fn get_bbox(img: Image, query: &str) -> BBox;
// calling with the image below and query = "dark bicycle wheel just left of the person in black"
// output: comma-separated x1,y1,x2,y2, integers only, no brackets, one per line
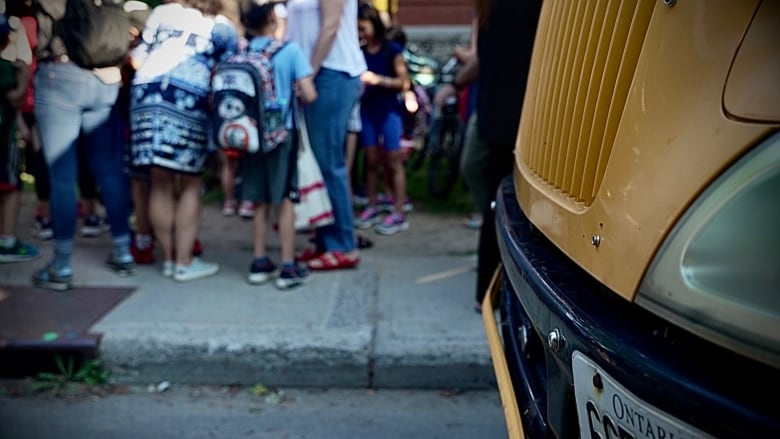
428,117,463,200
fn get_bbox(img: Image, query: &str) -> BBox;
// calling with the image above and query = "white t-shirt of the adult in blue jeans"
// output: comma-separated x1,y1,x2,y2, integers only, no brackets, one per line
287,0,366,77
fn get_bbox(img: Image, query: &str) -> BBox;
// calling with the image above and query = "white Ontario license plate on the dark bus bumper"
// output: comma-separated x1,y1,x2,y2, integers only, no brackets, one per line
572,351,713,439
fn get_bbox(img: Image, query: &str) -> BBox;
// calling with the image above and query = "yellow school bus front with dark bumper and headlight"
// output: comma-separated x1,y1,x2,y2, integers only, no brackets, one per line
483,0,780,439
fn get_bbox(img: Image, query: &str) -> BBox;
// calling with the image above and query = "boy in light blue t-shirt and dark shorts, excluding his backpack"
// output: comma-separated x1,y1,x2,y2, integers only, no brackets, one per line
240,0,317,289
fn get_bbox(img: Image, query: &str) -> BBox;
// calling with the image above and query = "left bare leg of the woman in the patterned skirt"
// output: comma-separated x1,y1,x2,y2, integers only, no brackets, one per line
149,166,175,261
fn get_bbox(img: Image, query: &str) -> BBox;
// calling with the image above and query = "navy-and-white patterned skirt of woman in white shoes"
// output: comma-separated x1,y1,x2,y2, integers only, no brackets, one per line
130,83,213,174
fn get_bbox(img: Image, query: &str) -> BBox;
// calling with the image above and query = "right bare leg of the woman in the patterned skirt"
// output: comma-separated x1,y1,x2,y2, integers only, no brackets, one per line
174,174,203,265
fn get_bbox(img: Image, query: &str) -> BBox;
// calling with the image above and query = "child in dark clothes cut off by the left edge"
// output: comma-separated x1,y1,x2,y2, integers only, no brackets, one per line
0,14,40,263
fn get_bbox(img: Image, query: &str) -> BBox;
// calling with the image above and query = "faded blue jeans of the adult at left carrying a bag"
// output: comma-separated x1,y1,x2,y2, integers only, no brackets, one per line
34,62,130,249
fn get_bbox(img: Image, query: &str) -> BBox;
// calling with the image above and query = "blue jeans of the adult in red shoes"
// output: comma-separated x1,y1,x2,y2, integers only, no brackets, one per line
303,68,360,252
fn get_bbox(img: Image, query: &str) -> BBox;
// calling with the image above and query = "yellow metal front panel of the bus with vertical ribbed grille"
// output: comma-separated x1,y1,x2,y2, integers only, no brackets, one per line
514,0,778,300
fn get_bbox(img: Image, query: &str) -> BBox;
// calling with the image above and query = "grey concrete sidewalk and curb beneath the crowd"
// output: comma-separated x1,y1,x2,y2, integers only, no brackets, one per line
0,193,495,388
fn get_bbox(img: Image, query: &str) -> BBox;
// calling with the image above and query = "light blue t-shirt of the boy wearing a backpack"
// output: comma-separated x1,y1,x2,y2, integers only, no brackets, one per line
247,37,314,129
